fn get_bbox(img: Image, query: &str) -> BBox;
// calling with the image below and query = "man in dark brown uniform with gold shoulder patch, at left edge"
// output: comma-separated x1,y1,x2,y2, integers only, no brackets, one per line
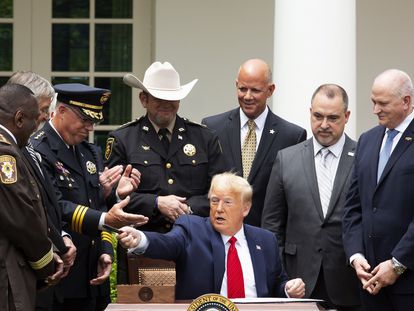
0,84,56,310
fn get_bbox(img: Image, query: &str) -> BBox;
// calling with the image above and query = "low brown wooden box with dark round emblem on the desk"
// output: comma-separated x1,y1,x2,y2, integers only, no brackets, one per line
117,284,175,303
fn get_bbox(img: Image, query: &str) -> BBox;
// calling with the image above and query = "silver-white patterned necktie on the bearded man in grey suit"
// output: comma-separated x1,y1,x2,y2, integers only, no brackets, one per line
317,148,332,217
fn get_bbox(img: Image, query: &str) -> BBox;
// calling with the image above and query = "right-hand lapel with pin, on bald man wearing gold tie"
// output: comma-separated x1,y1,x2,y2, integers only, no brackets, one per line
247,109,279,183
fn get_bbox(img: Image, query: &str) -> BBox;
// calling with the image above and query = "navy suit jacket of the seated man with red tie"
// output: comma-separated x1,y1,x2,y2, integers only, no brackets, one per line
145,215,287,299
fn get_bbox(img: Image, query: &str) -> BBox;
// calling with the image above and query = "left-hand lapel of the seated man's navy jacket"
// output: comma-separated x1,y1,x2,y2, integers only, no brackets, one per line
207,218,225,293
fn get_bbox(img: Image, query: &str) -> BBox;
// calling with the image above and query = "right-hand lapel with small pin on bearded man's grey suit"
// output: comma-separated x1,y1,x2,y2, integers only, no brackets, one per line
325,136,355,220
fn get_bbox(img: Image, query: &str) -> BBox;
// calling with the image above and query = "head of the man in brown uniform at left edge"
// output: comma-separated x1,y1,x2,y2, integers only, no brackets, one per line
0,84,39,147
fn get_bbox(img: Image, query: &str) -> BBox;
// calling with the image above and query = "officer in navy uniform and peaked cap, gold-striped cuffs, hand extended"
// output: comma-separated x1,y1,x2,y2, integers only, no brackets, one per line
31,83,149,311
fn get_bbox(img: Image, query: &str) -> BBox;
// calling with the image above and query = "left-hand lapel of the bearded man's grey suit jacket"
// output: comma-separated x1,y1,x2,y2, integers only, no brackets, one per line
302,138,324,221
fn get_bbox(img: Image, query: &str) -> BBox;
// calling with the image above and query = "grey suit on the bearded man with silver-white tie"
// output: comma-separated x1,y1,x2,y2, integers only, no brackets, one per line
262,137,359,306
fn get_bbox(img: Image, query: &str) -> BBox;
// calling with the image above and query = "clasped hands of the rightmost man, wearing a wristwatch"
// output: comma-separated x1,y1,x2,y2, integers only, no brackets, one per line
352,258,398,295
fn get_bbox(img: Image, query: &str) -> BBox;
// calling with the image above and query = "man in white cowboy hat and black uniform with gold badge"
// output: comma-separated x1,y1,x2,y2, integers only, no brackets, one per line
105,62,224,283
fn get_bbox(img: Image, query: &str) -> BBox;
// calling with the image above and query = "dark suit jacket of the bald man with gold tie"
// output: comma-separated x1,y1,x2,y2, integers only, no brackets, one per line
201,108,306,226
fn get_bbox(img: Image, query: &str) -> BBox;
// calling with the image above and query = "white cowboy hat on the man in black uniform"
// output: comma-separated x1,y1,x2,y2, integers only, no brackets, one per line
123,62,198,100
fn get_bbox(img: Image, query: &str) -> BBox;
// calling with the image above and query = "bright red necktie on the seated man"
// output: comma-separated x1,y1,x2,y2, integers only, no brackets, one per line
227,236,245,298
